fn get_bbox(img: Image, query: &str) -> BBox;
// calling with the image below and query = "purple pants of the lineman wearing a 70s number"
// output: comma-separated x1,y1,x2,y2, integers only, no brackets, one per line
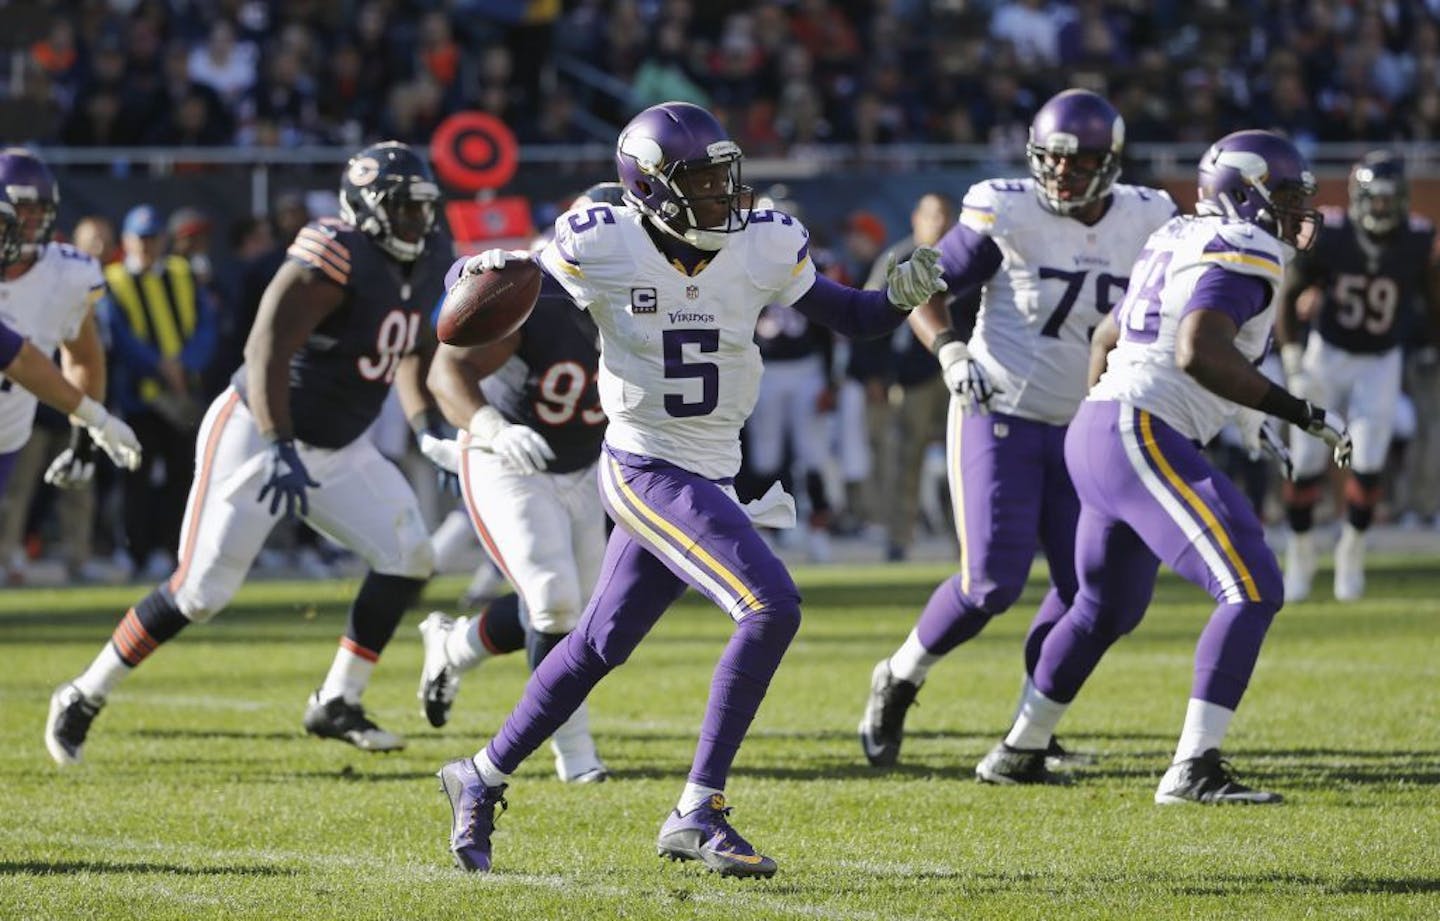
916,400,1080,673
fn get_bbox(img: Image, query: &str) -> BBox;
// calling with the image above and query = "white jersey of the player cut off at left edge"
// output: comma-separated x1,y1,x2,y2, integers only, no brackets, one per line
0,243,105,452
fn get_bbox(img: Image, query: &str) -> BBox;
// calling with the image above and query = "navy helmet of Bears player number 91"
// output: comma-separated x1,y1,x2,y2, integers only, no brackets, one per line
340,141,441,262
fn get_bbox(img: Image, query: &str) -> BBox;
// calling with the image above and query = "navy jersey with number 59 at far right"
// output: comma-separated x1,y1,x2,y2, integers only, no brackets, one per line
1295,209,1436,354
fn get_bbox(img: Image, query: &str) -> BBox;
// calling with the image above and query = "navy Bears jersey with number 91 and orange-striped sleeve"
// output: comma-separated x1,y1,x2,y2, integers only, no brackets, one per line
232,219,452,448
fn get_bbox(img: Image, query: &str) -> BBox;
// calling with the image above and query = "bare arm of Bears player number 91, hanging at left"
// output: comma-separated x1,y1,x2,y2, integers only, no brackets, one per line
245,262,346,440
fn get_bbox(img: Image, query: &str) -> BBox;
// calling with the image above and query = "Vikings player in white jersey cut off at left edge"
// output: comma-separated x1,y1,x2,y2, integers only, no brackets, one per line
0,147,140,489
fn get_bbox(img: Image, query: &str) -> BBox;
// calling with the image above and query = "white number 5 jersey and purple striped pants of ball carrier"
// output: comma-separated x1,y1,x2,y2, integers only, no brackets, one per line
487,204,904,789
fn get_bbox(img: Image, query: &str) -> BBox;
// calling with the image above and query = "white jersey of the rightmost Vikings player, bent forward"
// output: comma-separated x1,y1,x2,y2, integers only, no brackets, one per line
1090,216,1286,443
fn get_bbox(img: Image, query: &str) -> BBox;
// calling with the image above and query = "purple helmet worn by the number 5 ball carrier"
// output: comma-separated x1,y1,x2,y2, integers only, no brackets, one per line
615,102,753,249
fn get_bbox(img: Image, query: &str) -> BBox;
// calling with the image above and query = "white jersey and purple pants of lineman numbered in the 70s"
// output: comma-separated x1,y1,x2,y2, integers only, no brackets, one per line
916,178,1175,659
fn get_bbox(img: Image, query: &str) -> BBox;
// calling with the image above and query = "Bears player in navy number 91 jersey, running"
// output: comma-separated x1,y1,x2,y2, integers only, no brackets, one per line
45,142,452,764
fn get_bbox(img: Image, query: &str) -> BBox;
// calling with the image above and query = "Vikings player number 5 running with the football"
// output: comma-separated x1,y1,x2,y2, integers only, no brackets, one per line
439,102,945,876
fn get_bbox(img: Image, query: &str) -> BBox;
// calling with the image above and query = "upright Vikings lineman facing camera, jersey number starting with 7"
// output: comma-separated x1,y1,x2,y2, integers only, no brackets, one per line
860,89,1176,766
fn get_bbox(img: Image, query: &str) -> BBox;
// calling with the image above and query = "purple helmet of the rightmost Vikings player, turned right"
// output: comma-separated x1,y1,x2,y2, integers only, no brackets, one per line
1195,130,1320,249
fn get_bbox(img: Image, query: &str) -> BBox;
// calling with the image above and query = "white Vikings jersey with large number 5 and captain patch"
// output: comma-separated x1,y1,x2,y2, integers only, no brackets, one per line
540,204,815,479
